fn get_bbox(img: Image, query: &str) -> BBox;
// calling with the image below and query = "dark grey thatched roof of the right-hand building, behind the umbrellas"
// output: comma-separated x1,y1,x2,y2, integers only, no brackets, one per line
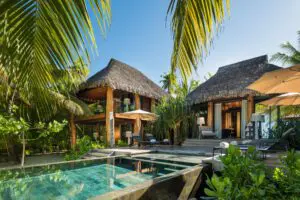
187,55,280,104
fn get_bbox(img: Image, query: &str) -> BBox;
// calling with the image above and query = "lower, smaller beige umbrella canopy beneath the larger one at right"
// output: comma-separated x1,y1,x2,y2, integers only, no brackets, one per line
259,93,300,106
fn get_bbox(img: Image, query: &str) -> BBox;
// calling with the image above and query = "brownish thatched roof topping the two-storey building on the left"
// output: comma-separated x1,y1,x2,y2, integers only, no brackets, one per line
81,59,166,99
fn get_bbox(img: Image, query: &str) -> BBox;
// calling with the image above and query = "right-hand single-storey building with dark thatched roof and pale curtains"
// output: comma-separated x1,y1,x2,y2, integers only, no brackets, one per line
187,55,280,138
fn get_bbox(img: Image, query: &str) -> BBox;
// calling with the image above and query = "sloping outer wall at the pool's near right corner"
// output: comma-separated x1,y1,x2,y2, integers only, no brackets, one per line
93,165,203,200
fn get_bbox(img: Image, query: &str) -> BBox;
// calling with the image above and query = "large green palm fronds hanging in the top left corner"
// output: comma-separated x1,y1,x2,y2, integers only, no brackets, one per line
0,0,111,113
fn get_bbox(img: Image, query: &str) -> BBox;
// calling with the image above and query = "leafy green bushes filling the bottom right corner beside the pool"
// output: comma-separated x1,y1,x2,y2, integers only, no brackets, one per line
205,146,300,200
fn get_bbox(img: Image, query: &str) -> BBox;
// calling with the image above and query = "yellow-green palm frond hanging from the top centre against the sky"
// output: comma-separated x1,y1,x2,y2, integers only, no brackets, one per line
168,0,230,82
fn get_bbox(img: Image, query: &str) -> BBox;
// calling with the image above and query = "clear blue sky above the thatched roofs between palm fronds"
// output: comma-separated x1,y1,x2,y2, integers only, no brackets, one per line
90,0,300,84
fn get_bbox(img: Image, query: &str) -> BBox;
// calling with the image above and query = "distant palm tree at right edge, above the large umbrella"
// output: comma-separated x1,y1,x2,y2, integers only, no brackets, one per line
271,31,300,65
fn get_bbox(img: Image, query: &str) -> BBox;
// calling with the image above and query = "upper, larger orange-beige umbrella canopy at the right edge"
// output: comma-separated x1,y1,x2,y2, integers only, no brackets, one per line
247,65,300,94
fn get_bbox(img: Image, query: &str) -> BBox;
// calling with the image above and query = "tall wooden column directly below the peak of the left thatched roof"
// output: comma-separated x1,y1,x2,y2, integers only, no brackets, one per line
105,87,114,144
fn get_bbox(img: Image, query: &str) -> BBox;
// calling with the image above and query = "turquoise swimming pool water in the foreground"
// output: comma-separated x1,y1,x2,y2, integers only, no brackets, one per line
0,157,197,199
